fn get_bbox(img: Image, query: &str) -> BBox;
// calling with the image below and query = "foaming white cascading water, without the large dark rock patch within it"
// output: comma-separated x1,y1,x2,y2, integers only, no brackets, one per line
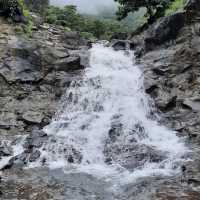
34,44,186,183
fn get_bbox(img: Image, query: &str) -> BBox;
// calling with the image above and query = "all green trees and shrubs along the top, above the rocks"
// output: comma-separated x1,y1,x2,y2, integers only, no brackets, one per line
0,0,186,41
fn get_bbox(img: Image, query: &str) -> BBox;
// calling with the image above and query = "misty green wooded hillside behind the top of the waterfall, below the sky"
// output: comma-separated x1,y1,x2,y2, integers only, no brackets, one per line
45,6,150,41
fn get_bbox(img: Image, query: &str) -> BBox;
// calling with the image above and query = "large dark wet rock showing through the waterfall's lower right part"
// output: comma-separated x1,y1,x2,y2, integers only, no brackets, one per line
104,115,166,171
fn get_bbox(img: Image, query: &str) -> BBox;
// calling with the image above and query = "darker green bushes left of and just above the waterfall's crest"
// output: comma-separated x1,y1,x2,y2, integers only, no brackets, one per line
45,6,122,40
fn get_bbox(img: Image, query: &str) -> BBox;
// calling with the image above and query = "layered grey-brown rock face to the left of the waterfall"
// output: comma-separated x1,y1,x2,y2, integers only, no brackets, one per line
0,18,88,170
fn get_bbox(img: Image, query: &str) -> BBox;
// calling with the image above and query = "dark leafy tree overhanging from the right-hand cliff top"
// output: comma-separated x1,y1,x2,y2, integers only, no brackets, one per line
115,0,175,24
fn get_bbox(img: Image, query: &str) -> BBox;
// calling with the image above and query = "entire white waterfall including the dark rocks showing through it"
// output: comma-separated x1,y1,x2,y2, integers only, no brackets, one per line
0,44,187,199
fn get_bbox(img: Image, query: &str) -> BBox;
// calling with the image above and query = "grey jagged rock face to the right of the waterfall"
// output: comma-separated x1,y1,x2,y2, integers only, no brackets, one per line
133,0,200,200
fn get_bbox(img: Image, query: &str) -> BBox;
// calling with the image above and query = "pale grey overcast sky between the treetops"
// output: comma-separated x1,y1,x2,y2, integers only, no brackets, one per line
50,0,115,14
